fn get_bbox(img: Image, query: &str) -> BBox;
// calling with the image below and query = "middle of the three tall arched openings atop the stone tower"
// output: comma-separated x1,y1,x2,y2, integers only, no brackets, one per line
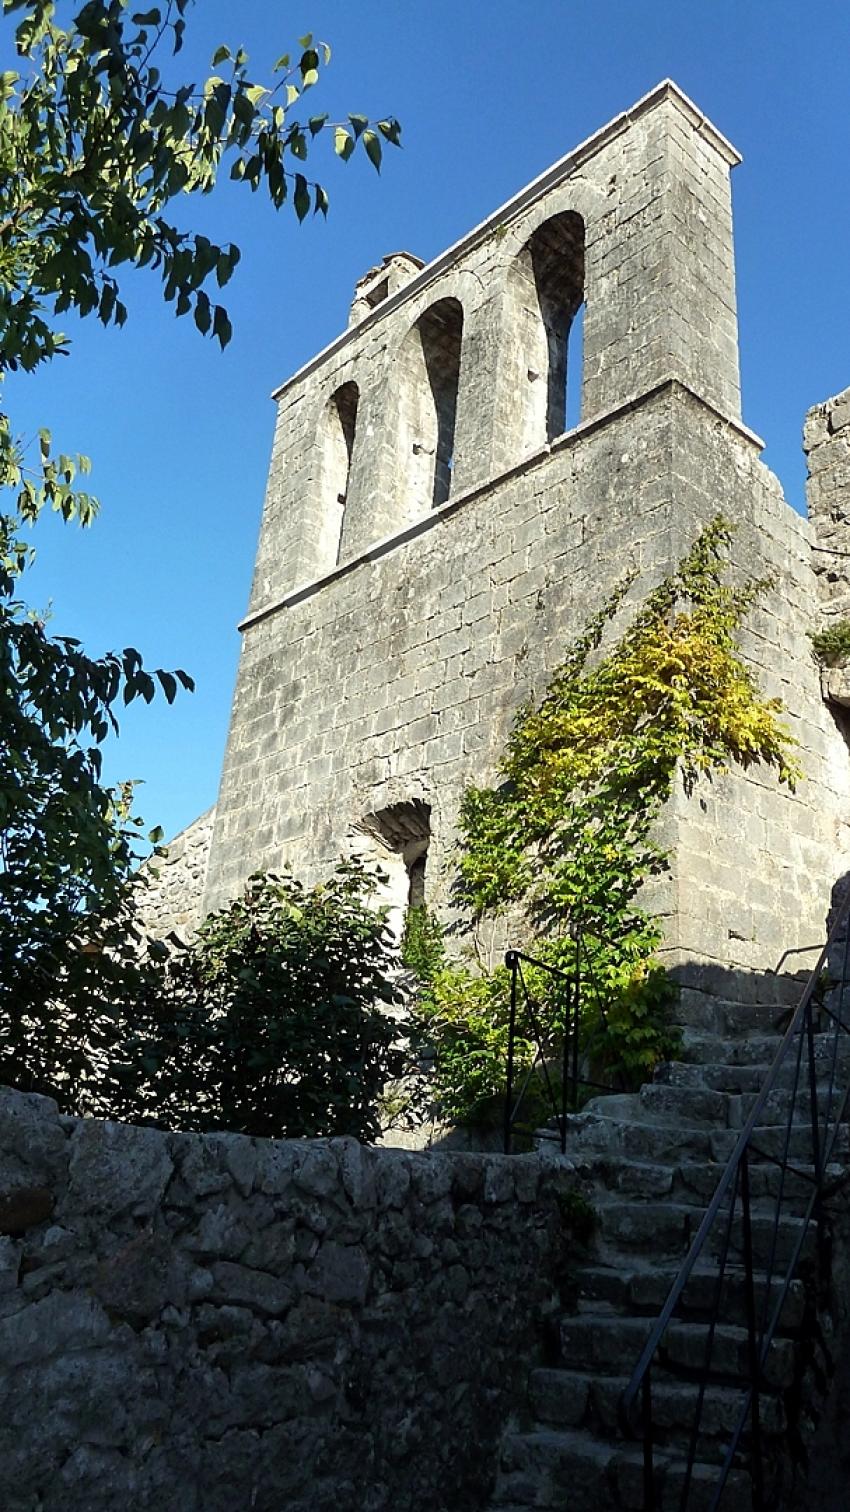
399,298,463,519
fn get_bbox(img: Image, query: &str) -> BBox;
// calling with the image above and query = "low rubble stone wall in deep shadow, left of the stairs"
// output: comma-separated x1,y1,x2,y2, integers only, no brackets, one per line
0,1092,573,1512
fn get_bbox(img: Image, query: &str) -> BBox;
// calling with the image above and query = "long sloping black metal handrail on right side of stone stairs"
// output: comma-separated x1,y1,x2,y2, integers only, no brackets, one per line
620,892,850,1512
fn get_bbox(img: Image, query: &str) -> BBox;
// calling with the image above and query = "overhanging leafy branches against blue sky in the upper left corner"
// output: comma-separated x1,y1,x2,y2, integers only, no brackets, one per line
0,0,399,370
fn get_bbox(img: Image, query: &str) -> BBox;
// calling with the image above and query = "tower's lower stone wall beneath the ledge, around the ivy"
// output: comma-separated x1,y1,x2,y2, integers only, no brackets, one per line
199,373,850,971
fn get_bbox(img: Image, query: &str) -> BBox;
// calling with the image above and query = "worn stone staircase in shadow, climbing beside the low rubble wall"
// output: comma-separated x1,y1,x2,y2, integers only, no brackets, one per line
490,983,850,1512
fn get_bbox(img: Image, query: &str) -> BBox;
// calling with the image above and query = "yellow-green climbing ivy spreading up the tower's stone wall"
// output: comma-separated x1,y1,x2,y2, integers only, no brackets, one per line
419,516,802,1120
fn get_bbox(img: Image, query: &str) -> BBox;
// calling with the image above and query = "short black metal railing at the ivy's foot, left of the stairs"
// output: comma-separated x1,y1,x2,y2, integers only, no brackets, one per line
504,931,622,1155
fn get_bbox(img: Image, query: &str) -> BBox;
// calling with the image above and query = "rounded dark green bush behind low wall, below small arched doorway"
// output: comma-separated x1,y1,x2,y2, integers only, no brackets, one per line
127,862,402,1140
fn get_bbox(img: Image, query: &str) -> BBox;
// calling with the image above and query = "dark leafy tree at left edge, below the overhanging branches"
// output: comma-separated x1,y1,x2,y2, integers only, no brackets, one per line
0,486,192,1003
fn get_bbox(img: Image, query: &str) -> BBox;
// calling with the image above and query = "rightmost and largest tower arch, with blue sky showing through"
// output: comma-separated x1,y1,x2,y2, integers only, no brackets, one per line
508,210,584,452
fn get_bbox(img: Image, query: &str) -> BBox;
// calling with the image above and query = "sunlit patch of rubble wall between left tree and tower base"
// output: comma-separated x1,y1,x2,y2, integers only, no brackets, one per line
136,807,215,939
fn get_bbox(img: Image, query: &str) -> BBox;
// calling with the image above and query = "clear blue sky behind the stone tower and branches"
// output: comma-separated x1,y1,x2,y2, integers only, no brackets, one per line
6,0,850,833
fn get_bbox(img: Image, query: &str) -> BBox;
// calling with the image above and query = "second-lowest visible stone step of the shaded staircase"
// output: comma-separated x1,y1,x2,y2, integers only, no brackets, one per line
529,1368,786,1433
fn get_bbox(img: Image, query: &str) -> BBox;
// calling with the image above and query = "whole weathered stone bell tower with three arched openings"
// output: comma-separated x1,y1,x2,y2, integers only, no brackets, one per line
176,83,850,971
